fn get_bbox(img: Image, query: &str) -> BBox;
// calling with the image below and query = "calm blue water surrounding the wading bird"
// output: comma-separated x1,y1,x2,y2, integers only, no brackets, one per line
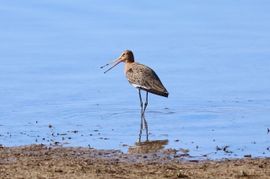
0,0,270,157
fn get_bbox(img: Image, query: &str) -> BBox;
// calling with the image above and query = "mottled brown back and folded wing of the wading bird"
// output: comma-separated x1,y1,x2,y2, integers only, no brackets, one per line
126,62,169,97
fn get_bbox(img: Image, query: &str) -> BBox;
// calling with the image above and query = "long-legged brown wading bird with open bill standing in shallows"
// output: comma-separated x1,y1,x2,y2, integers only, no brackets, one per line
100,50,169,142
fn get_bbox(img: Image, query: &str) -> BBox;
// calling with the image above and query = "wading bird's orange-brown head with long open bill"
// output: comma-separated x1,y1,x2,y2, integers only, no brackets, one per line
100,50,134,73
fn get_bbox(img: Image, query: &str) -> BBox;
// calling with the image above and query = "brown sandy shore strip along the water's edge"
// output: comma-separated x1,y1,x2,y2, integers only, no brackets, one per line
0,145,270,178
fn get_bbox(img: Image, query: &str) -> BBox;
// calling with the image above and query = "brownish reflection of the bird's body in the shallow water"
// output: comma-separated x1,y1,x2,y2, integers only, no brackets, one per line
128,140,169,154
